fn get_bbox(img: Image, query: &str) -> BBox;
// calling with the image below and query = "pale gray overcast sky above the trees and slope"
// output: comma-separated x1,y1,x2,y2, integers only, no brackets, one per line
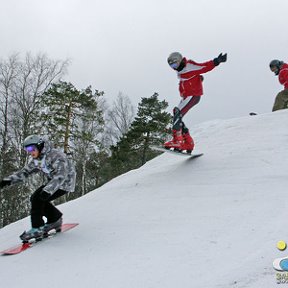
0,0,288,126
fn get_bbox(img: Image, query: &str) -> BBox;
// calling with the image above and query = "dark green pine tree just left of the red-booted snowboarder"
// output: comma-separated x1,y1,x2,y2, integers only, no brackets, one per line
111,93,171,174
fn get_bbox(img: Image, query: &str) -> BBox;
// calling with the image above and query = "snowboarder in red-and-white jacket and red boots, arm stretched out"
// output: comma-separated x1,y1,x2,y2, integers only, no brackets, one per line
164,52,227,153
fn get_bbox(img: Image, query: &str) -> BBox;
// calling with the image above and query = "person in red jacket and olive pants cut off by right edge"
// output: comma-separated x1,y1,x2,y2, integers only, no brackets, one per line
269,59,288,112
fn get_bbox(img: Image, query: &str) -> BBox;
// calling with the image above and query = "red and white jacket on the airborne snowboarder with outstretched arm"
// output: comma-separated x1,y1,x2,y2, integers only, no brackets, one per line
177,58,215,99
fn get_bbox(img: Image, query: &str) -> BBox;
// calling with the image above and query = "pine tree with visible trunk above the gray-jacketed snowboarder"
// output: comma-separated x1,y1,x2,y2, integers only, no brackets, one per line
41,81,101,153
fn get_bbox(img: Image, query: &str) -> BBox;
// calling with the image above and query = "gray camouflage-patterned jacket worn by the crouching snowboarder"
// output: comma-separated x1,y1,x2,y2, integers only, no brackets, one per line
5,141,76,195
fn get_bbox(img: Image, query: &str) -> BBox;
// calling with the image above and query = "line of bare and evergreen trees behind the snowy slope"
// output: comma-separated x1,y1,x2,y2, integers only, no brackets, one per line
0,53,171,227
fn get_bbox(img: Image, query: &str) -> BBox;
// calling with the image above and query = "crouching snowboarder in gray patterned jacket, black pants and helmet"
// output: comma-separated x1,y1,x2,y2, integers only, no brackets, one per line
0,135,76,241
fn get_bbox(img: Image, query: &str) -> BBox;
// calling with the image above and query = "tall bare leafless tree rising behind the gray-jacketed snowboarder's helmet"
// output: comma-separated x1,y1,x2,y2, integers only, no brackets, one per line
11,53,68,165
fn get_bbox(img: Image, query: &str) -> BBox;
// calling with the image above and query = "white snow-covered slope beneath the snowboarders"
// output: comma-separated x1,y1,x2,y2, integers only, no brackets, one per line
0,110,288,288
